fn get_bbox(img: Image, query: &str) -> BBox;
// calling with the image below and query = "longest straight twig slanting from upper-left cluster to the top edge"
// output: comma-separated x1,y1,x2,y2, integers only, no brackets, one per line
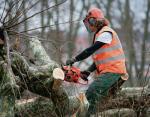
6,0,67,29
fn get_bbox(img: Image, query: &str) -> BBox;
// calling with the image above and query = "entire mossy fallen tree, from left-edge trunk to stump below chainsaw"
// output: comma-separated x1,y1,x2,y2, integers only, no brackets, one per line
1,32,84,117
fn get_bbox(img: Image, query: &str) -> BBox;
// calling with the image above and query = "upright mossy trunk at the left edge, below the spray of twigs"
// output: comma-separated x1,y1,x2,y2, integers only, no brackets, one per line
0,30,18,117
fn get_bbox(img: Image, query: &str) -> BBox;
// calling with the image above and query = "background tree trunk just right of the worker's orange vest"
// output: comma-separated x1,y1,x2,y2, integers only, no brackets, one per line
122,0,136,86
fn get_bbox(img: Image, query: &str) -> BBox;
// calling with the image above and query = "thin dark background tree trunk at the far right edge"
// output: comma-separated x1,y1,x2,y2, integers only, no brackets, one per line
139,0,150,85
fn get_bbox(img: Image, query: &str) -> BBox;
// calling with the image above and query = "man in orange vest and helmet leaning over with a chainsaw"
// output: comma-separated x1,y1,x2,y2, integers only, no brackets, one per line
66,8,127,117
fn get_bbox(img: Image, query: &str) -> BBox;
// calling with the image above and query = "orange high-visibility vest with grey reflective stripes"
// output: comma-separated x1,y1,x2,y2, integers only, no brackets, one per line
93,26,127,75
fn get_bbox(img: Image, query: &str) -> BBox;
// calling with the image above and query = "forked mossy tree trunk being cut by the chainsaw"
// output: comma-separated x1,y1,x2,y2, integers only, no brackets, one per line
11,38,80,116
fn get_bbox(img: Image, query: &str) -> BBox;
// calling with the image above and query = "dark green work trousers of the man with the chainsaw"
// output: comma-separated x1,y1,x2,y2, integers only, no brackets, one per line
86,73,124,117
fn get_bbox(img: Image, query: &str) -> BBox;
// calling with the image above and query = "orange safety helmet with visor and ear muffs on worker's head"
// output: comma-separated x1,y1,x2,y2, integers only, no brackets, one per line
83,8,109,32
